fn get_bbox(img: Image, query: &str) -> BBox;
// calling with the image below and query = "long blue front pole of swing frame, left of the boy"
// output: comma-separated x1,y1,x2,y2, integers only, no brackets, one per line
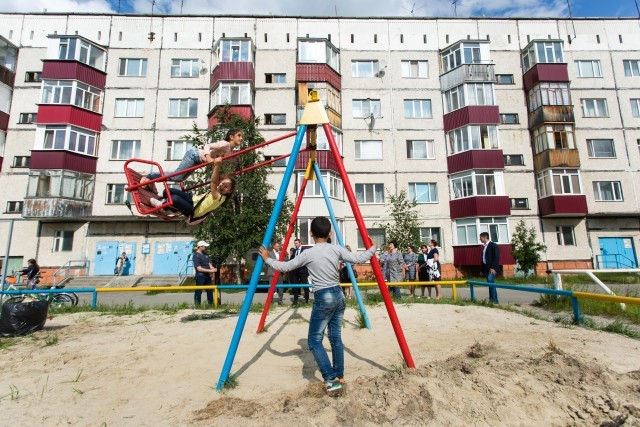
216,125,307,391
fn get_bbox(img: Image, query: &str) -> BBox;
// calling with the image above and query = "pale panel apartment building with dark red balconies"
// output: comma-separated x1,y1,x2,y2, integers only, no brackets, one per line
0,14,640,276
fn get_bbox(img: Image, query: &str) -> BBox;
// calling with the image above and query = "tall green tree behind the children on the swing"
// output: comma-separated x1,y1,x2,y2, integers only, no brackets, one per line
185,106,293,278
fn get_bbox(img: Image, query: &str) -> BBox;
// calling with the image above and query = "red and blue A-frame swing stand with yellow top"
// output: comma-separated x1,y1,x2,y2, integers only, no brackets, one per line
216,91,415,391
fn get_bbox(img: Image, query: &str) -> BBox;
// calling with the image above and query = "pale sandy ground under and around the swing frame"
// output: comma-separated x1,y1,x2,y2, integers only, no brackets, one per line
0,304,640,426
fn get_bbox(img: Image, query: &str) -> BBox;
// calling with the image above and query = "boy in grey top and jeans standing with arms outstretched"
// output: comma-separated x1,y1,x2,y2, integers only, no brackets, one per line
260,217,376,393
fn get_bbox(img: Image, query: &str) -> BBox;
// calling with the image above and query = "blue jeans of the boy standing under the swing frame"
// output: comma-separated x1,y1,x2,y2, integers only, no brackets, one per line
308,286,347,381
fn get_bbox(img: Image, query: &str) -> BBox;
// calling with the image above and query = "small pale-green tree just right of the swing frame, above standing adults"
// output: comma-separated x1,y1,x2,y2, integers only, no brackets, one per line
376,190,420,251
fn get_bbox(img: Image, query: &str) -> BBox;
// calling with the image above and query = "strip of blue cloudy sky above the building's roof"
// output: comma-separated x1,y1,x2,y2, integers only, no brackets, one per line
0,0,640,17
